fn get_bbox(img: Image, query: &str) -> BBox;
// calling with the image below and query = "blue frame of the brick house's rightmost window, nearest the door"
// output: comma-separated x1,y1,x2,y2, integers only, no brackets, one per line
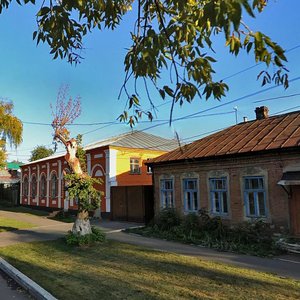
243,175,268,219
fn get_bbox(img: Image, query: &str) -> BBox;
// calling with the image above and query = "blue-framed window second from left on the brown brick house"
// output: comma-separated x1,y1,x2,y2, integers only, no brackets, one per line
183,179,199,212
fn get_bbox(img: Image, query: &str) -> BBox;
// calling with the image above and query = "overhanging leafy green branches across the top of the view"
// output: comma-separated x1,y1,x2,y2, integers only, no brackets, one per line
0,0,288,125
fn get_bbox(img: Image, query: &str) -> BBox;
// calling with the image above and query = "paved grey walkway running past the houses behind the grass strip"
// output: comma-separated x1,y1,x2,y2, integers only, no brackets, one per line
0,211,300,279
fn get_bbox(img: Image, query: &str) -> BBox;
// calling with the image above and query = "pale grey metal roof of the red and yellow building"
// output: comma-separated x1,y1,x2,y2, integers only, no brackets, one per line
23,131,178,167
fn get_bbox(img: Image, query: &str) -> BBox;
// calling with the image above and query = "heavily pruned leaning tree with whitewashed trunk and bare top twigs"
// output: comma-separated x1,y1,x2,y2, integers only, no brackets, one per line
52,87,101,236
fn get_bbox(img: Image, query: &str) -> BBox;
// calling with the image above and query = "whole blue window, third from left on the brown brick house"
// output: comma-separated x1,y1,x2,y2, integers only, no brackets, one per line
209,177,228,215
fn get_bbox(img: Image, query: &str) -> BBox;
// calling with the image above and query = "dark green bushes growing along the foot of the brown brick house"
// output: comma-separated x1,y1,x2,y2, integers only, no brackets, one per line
132,209,278,256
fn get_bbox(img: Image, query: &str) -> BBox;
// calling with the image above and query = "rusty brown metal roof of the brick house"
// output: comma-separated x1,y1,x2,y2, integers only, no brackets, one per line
151,111,300,163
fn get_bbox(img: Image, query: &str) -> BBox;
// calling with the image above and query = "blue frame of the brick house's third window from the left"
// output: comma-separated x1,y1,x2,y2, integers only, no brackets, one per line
208,176,229,217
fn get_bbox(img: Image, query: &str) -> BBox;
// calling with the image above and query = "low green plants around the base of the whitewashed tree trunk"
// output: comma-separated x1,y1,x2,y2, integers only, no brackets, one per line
65,227,105,246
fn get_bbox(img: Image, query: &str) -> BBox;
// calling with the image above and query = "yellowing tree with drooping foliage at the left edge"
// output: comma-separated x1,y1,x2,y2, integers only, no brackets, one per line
0,100,23,168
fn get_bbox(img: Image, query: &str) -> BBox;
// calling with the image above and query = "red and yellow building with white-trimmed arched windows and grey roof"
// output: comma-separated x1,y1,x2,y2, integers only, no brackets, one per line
20,131,177,218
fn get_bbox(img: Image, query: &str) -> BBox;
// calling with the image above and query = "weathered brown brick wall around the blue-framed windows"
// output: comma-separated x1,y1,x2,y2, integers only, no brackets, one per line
152,151,300,228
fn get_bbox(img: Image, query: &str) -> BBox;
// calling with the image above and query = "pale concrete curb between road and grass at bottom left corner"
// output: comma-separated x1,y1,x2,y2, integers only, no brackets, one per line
0,257,57,300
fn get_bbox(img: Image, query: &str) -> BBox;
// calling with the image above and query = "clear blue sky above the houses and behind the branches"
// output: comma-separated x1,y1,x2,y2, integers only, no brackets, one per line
0,0,300,162
